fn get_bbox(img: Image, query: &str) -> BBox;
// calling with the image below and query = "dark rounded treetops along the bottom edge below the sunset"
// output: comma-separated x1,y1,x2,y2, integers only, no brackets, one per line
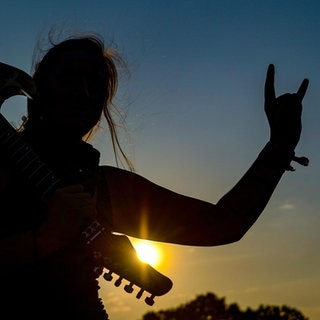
142,292,308,320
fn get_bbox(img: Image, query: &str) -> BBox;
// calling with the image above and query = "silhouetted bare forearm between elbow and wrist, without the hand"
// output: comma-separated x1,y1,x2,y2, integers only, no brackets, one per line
217,143,294,240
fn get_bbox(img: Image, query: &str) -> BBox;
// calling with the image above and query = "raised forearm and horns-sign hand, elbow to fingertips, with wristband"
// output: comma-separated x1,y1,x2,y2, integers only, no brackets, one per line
217,65,309,238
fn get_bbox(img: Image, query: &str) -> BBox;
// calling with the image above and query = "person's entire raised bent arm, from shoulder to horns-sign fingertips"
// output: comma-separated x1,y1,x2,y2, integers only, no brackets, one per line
101,65,308,246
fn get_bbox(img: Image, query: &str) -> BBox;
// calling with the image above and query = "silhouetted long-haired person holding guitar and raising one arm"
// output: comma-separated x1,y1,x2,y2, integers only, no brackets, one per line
0,35,308,320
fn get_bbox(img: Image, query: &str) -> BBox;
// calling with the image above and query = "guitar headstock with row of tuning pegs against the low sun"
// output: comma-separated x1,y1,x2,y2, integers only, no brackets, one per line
83,221,172,305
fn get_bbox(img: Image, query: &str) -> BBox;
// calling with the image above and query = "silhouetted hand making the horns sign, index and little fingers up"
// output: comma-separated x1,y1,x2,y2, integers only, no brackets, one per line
264,64,309,150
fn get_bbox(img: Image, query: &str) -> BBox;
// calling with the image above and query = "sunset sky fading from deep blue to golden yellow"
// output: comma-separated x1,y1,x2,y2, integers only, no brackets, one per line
0,0,320,320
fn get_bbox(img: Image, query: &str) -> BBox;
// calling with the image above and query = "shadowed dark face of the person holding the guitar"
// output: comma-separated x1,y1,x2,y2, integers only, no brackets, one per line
40,50,108,137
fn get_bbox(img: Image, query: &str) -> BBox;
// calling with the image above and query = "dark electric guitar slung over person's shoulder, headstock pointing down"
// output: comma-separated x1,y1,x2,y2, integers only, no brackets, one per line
0,63,172,305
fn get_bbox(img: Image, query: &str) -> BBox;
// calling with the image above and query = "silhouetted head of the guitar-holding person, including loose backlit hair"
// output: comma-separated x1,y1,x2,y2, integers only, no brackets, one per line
24,35,130,170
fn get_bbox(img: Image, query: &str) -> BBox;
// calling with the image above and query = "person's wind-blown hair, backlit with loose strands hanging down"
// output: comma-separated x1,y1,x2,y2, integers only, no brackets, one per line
22,34,133,170
